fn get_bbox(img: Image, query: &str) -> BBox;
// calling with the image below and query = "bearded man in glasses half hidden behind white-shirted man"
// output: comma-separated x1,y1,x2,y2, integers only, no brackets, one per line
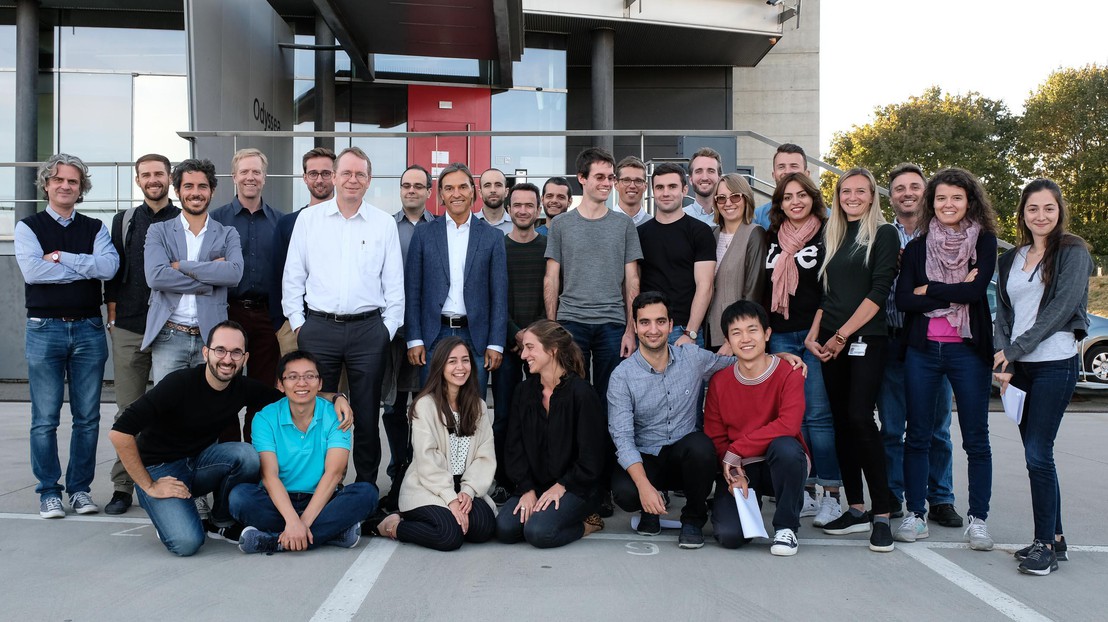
269,146,335,356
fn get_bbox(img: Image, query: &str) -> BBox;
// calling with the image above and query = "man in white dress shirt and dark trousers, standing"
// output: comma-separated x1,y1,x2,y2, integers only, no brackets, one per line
281,146,404,483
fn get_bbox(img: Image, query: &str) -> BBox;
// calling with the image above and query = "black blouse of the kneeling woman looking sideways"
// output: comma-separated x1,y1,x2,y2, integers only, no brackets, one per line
504,374,611,498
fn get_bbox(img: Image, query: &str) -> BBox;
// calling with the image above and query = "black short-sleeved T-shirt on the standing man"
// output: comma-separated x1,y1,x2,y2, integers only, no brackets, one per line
638,216,716,326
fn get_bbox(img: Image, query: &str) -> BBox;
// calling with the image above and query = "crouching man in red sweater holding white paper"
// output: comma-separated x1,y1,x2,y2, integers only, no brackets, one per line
704,300,809,557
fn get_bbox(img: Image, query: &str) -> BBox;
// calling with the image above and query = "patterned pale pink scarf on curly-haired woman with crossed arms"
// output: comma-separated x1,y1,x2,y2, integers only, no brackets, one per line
923,218,981,339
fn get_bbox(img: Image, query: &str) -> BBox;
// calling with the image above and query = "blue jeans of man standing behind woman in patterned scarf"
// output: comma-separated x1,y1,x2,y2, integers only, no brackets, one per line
878,338,954,507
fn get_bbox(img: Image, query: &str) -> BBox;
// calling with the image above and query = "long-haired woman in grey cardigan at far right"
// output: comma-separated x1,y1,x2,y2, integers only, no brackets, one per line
993,180,1092,575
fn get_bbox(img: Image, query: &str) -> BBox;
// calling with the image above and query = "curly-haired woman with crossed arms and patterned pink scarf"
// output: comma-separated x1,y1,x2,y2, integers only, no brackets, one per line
894,169,996,551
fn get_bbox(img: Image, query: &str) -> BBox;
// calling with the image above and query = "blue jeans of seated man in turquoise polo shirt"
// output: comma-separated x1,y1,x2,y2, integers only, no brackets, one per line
229,481,377,549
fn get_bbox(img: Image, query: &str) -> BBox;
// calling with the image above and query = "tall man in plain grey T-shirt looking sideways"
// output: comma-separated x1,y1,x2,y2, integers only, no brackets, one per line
543,147,643,408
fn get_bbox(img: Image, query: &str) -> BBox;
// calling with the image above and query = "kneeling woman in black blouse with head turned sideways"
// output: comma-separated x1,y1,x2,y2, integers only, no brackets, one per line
496,319,607,549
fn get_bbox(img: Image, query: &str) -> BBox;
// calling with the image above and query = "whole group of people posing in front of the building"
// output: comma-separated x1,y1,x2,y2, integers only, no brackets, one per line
16,144,1091,574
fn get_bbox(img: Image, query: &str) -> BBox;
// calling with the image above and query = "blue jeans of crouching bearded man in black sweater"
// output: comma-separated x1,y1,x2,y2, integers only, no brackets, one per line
135,442,259,557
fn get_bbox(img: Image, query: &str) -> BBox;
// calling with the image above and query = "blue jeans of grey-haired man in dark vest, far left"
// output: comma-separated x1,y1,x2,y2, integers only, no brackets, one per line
25,317,107,500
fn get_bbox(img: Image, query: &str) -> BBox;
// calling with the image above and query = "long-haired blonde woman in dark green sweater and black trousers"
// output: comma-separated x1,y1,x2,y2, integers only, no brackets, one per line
804,169,900,552
